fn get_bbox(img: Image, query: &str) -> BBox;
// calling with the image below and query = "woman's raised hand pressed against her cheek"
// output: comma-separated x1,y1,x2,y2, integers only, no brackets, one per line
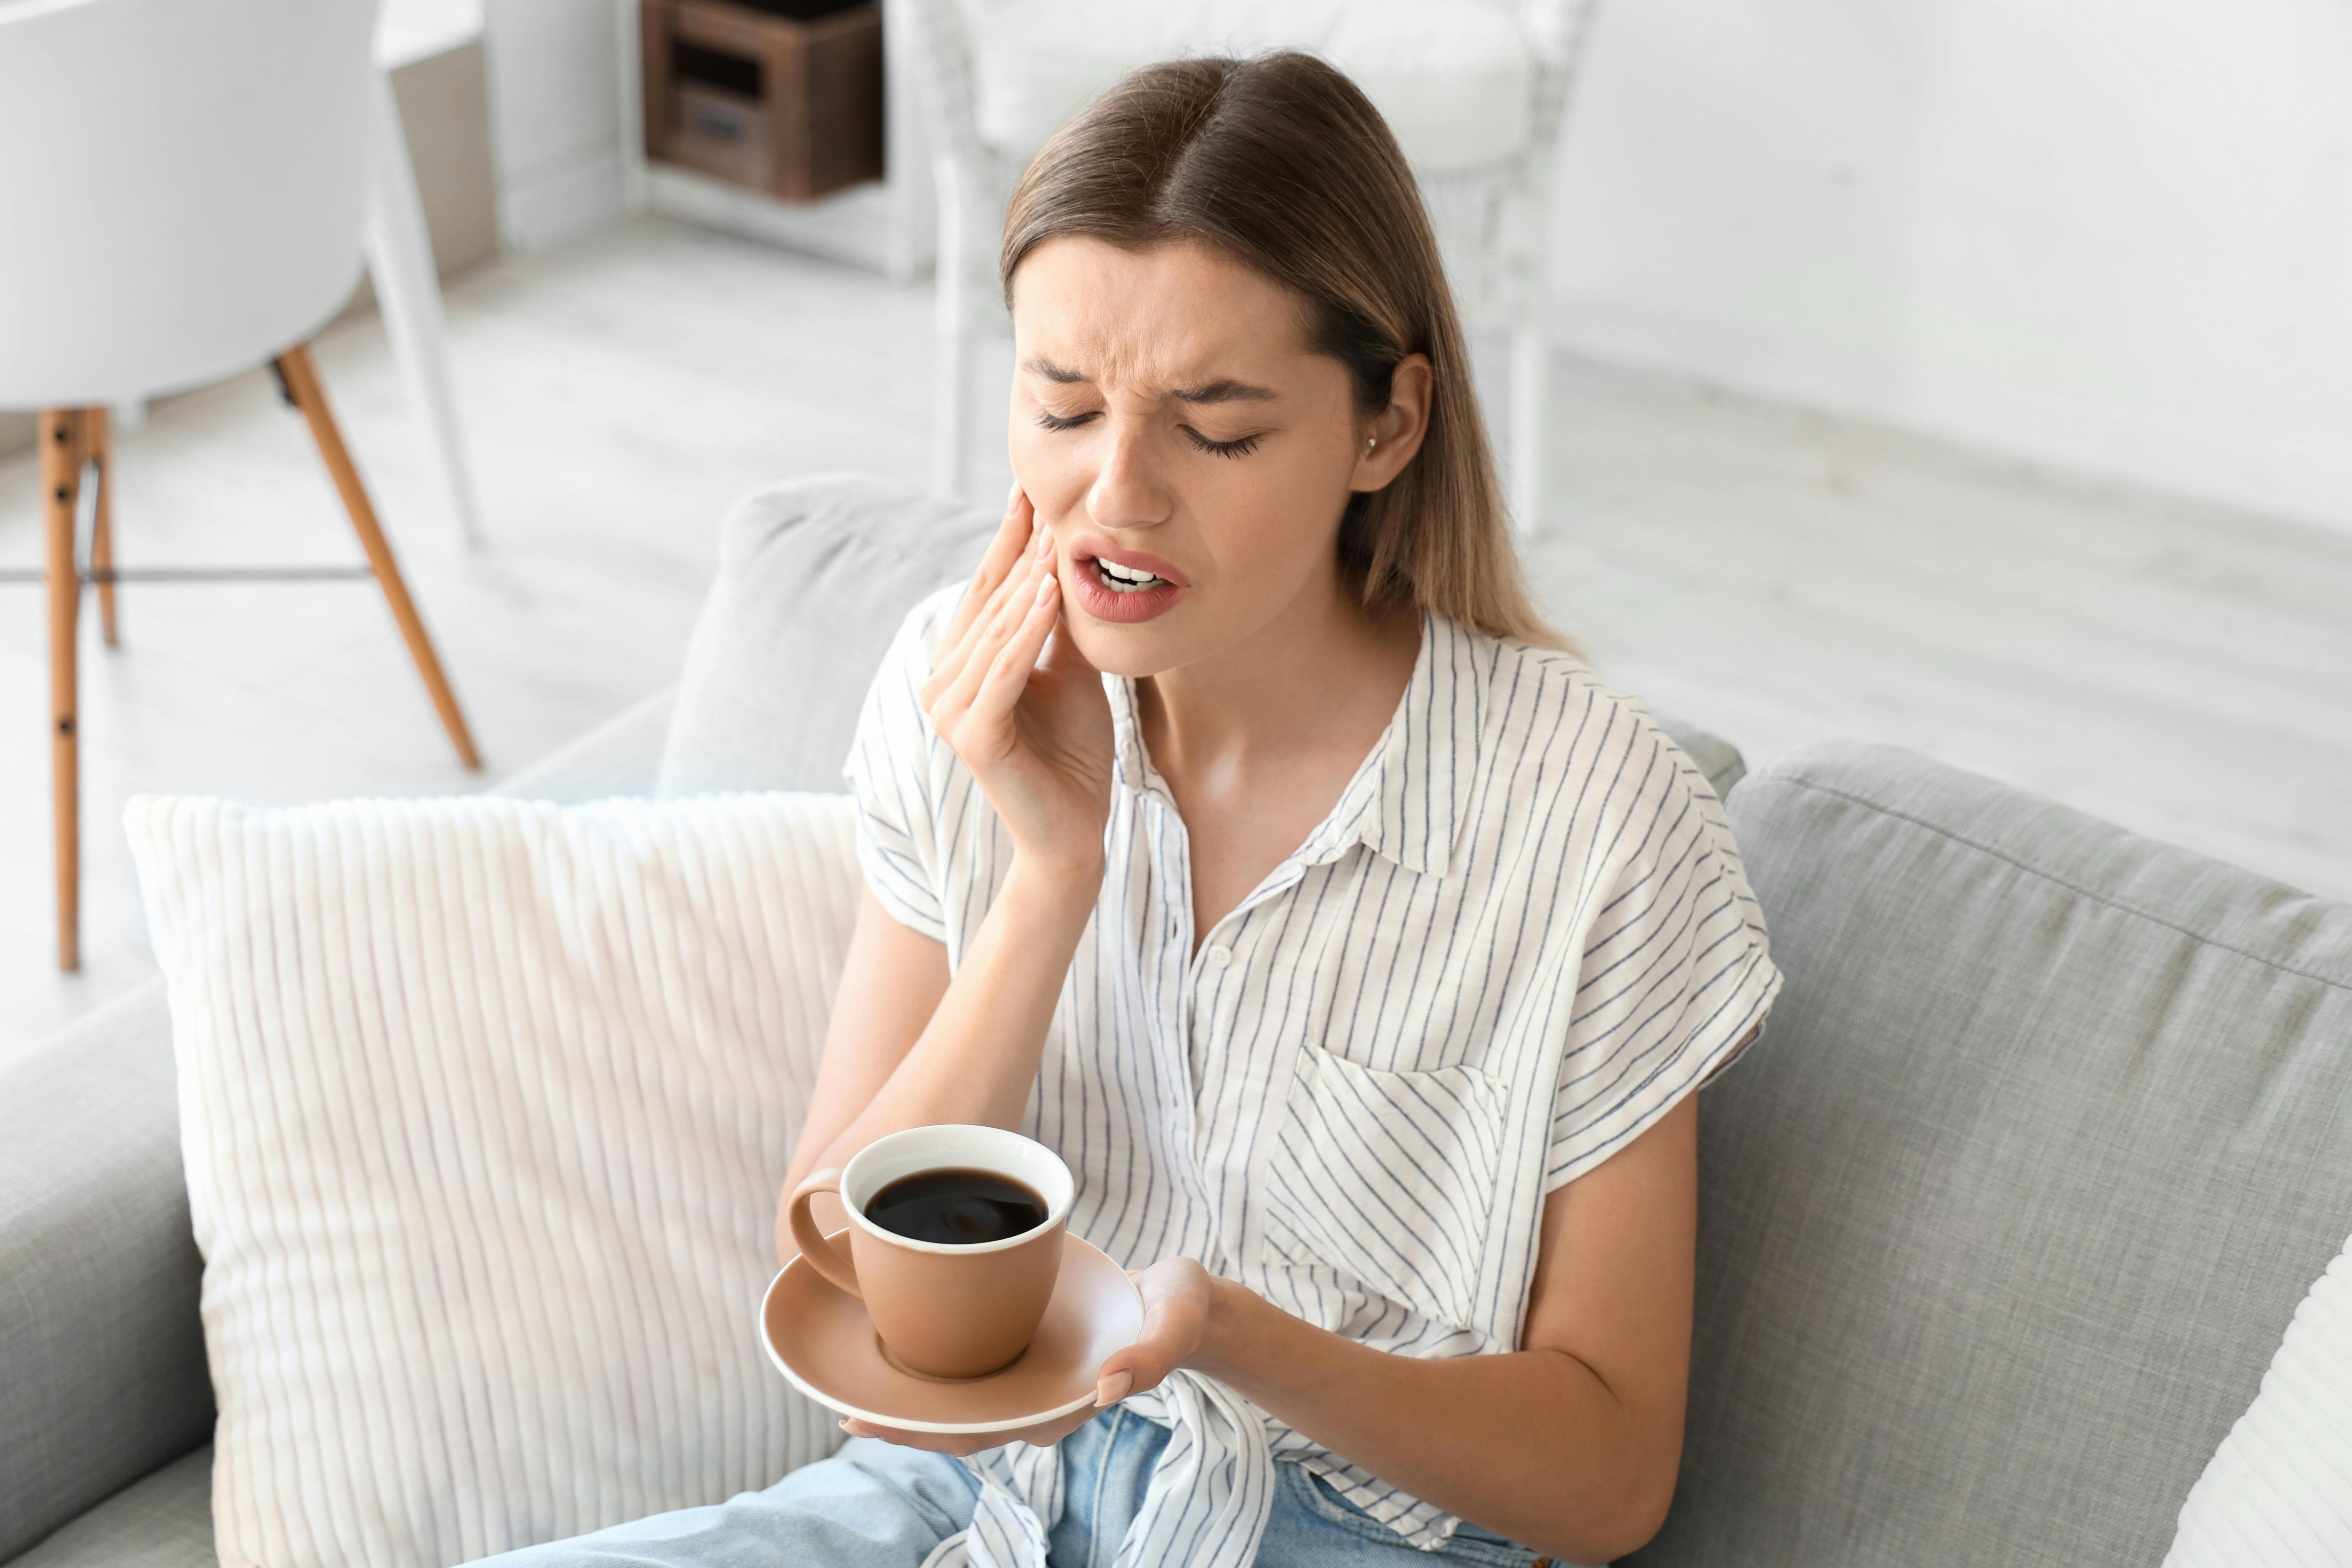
920,484,1113,877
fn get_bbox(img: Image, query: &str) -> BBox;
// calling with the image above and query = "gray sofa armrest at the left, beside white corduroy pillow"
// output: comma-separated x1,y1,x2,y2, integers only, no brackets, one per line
0,983,212,1561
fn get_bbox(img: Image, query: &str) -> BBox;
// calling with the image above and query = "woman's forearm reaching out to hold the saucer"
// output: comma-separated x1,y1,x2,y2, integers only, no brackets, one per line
1188,1279,1682,1563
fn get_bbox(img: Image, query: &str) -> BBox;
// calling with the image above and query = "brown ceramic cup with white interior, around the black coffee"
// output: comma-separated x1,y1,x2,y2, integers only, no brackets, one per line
790,1124,1075,1378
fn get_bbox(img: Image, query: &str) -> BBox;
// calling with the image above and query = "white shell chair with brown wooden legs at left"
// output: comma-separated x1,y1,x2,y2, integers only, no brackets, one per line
0,0,480,968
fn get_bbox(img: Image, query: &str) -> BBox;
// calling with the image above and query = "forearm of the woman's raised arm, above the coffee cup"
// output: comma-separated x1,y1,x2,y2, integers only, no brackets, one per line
793,860,1101,1178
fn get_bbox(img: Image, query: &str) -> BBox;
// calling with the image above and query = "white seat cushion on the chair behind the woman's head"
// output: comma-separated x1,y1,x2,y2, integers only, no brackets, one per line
957,0,1536,174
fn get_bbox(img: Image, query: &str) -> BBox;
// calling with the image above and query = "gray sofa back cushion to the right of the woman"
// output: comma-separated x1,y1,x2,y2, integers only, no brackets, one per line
1628,745,2352,1568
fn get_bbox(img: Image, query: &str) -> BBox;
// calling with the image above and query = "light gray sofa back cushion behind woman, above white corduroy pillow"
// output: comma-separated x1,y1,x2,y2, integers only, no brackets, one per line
654,475,1745,794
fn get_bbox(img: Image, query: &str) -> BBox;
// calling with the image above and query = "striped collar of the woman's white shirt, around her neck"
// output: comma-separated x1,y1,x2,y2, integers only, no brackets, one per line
1103,611,1486,875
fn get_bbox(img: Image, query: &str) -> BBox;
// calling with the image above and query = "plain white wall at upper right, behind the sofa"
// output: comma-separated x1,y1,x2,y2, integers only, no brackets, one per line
1555,0,2352,529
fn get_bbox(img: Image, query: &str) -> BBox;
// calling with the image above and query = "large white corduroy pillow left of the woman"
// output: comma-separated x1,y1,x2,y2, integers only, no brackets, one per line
127,794,859,1568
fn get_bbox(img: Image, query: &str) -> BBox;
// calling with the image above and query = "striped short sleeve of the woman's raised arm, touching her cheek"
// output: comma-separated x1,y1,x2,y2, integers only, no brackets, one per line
842,590,962,943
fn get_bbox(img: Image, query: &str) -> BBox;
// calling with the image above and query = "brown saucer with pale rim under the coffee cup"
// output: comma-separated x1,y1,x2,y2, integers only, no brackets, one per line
760,1232,1143,1432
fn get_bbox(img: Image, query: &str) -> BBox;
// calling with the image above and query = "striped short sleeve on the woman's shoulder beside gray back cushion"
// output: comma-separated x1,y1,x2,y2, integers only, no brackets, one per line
1543,745,1780,1192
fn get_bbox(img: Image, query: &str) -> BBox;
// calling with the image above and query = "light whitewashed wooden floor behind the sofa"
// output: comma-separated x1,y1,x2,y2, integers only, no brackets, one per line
0,223,2352,1058
